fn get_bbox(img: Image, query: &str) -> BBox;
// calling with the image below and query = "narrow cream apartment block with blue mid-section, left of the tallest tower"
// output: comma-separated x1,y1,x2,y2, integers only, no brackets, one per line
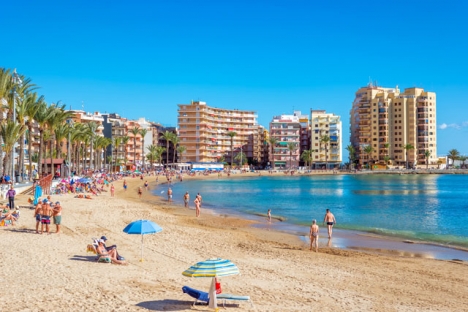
310,110,343,169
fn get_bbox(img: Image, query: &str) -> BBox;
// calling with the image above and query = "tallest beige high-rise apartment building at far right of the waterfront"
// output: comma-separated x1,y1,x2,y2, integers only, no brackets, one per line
350,83,437,167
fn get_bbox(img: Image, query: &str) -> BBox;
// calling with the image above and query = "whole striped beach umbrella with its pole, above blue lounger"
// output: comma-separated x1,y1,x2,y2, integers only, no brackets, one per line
182,258,239,309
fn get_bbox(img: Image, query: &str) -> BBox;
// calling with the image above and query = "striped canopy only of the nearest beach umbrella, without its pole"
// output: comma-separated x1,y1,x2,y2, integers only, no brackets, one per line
182,258,239,277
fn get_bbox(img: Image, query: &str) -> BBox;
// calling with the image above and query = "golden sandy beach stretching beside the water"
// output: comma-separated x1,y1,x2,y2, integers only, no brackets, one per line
0,177,468,311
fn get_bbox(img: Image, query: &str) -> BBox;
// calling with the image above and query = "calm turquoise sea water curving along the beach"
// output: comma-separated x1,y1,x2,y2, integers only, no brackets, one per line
155,174,468,247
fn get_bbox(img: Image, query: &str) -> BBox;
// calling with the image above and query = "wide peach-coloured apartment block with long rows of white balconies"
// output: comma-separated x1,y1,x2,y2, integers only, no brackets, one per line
178,101,258,163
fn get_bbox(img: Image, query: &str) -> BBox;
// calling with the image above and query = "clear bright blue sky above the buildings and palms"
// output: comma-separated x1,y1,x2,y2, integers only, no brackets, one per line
0,0,468,155
